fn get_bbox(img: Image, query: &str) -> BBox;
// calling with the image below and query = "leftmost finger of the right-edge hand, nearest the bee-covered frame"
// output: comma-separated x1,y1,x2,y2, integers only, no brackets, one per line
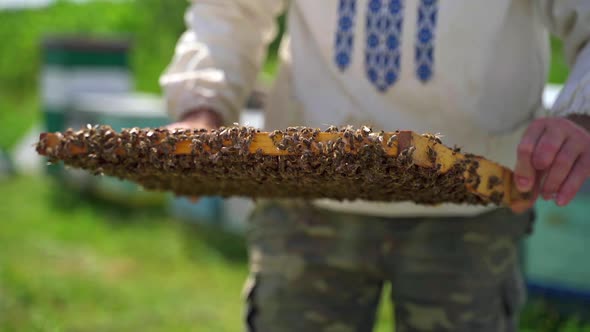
514,120,545,192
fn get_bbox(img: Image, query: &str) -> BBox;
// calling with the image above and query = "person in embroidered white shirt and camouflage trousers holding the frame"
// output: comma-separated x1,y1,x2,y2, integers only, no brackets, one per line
161,0,590,332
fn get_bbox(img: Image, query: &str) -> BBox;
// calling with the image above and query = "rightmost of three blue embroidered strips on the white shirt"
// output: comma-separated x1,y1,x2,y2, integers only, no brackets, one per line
415,0,438,83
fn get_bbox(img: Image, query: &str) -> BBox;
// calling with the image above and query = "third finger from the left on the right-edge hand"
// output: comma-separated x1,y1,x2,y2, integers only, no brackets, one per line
541,139,584,200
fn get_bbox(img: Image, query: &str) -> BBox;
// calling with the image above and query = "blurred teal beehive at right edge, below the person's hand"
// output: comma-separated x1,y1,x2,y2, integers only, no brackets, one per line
524,182,590,314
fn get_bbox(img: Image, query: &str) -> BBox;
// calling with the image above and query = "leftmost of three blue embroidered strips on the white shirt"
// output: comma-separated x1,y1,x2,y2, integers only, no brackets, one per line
334,0,356,71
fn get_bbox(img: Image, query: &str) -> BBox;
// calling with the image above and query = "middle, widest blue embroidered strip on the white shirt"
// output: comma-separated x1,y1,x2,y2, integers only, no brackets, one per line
365,0,404,92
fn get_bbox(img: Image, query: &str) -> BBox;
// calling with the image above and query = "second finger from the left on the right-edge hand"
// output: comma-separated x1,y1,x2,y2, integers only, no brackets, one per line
532,121,567,171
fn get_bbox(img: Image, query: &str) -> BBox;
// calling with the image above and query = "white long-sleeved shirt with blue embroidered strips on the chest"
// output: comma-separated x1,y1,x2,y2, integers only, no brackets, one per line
161,0,590,216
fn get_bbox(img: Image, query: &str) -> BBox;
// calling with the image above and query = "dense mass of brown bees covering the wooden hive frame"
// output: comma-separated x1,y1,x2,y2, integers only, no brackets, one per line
37,125,502,205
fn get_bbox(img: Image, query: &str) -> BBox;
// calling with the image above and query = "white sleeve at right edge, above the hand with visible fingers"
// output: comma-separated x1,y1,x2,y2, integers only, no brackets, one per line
538,0,590,116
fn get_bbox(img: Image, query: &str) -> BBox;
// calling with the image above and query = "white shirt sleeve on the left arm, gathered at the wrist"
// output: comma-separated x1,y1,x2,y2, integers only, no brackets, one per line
160,0,288,123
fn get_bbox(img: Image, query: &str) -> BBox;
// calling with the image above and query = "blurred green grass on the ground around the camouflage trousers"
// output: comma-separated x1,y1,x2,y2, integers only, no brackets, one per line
0,177,590,332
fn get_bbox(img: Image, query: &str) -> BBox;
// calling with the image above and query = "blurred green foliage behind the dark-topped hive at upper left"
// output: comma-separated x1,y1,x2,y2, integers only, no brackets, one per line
0,0,284,97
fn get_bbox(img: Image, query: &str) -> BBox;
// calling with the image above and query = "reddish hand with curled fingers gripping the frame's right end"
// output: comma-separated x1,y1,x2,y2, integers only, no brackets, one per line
512,115,590,213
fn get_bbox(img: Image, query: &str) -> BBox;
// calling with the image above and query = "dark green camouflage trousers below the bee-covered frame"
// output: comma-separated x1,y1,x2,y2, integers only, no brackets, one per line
245,202,533,332
